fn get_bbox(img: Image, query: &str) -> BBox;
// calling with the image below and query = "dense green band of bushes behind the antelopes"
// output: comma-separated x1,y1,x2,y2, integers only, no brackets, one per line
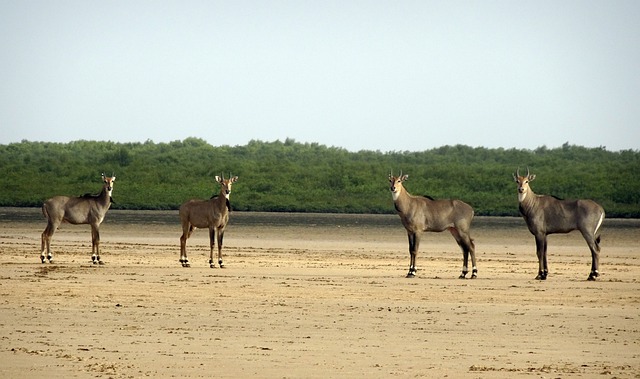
0,138,640,217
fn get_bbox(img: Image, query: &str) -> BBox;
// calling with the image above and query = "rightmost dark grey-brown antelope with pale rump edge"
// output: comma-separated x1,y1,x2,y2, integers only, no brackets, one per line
513,168,604,280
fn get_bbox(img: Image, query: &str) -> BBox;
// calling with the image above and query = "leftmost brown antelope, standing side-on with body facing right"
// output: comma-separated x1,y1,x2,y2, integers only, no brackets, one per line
40,174,116,264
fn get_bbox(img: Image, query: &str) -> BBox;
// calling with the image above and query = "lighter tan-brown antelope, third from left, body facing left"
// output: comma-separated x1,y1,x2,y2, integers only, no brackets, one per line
389,174,478,279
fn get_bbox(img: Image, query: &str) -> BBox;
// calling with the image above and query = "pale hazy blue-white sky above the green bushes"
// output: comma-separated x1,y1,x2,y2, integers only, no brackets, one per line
0,0,640,151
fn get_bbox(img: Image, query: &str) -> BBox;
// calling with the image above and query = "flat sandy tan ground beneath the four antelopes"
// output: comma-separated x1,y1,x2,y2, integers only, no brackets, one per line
0,210,640,378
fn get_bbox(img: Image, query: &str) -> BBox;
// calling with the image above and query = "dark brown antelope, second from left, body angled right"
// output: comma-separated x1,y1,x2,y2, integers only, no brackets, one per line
180,175,238,268
